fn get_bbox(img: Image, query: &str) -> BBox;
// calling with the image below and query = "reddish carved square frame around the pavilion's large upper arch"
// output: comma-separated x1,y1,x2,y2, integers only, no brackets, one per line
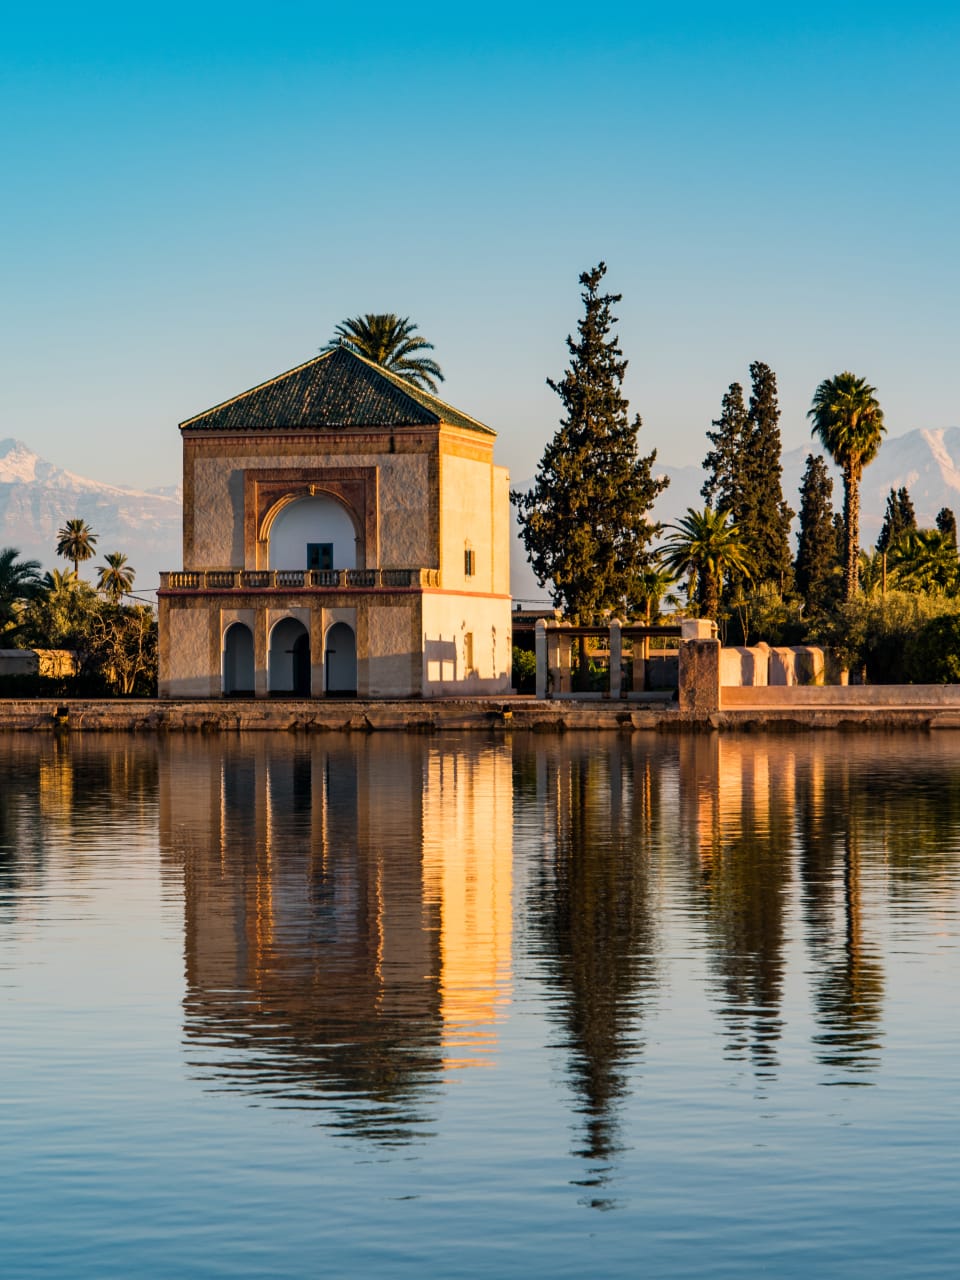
243,467,380,568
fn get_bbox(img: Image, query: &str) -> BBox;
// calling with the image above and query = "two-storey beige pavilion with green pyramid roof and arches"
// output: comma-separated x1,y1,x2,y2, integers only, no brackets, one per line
159,347,511,698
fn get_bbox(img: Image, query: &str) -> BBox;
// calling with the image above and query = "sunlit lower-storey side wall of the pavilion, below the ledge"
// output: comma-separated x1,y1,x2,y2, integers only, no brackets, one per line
422,591,513,698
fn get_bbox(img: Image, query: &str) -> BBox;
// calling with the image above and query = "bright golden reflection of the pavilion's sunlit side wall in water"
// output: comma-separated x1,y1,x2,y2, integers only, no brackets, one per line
424,746,513,1069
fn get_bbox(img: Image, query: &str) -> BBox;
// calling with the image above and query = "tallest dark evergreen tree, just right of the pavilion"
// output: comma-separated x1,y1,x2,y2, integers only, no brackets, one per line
511,262,667,623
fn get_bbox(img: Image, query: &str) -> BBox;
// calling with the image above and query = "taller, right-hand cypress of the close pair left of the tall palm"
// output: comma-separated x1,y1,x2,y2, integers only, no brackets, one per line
737,360,794,593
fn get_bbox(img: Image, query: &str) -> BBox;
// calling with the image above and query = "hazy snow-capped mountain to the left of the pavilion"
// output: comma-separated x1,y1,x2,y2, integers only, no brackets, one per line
0,439,182,591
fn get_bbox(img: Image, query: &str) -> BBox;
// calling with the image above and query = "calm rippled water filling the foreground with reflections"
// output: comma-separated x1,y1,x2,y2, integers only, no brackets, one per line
0,732,960,1280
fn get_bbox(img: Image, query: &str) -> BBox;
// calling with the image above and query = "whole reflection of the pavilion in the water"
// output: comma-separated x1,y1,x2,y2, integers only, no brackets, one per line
160,737,512,1138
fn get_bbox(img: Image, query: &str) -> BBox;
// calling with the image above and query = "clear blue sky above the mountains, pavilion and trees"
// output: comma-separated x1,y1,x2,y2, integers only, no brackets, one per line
0,3,960,498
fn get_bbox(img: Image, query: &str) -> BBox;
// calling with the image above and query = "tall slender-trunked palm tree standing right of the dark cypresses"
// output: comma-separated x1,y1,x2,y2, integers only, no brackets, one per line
806,372,886,600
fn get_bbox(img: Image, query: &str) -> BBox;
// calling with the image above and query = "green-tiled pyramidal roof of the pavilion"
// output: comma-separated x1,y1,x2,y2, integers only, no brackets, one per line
180,347,497,435
